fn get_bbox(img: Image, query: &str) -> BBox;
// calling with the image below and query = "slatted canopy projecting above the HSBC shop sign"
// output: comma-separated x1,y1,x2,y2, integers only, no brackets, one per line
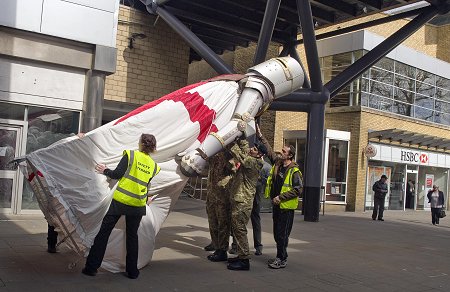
369,129,450,151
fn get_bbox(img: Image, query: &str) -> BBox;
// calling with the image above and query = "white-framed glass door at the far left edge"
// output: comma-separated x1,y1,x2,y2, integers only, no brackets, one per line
0,124,22,213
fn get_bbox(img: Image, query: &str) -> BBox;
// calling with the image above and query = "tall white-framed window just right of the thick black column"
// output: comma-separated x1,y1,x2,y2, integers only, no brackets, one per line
326,139,348,202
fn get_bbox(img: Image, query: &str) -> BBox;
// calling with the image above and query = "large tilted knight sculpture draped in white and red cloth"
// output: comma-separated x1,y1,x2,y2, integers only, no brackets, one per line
22,57,304,272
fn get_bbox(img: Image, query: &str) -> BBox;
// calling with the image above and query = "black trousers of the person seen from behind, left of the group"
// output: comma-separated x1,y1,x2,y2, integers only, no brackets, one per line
86,215,142,276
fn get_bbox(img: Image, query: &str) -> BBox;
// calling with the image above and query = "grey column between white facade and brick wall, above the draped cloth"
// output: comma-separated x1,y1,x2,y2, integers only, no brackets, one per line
81,70,106,133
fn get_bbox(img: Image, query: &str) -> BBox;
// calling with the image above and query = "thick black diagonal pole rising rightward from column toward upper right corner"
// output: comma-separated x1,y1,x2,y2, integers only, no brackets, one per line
326,6,439,97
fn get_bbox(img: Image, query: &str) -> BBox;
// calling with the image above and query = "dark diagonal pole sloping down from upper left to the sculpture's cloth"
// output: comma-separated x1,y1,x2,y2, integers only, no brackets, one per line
154,6,234,74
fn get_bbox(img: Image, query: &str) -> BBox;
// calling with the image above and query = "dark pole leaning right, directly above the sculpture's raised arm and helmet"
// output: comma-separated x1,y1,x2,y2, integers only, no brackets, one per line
253,0,281,65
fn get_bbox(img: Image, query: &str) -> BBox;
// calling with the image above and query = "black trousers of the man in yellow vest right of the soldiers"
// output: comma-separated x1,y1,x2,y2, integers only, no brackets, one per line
272,205,294,261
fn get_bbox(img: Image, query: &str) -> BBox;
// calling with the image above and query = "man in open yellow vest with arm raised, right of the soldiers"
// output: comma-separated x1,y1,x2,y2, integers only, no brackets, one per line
256,127,303,269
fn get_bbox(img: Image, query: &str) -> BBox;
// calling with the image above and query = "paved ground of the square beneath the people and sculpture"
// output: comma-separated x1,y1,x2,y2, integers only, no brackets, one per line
0,198,450,292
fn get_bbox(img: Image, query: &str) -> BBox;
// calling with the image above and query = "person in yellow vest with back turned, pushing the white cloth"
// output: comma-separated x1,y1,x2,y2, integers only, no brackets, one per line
82,134,160,279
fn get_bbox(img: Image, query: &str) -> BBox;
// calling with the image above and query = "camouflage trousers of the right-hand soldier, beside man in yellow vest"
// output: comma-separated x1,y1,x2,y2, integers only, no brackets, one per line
231,197,253,259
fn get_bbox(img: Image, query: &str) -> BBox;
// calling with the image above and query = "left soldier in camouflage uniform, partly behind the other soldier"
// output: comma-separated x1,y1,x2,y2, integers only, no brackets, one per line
206,151,231,262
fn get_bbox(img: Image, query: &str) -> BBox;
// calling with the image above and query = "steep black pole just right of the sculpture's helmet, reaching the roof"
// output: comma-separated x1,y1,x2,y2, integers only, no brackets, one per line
297,0,323,92
